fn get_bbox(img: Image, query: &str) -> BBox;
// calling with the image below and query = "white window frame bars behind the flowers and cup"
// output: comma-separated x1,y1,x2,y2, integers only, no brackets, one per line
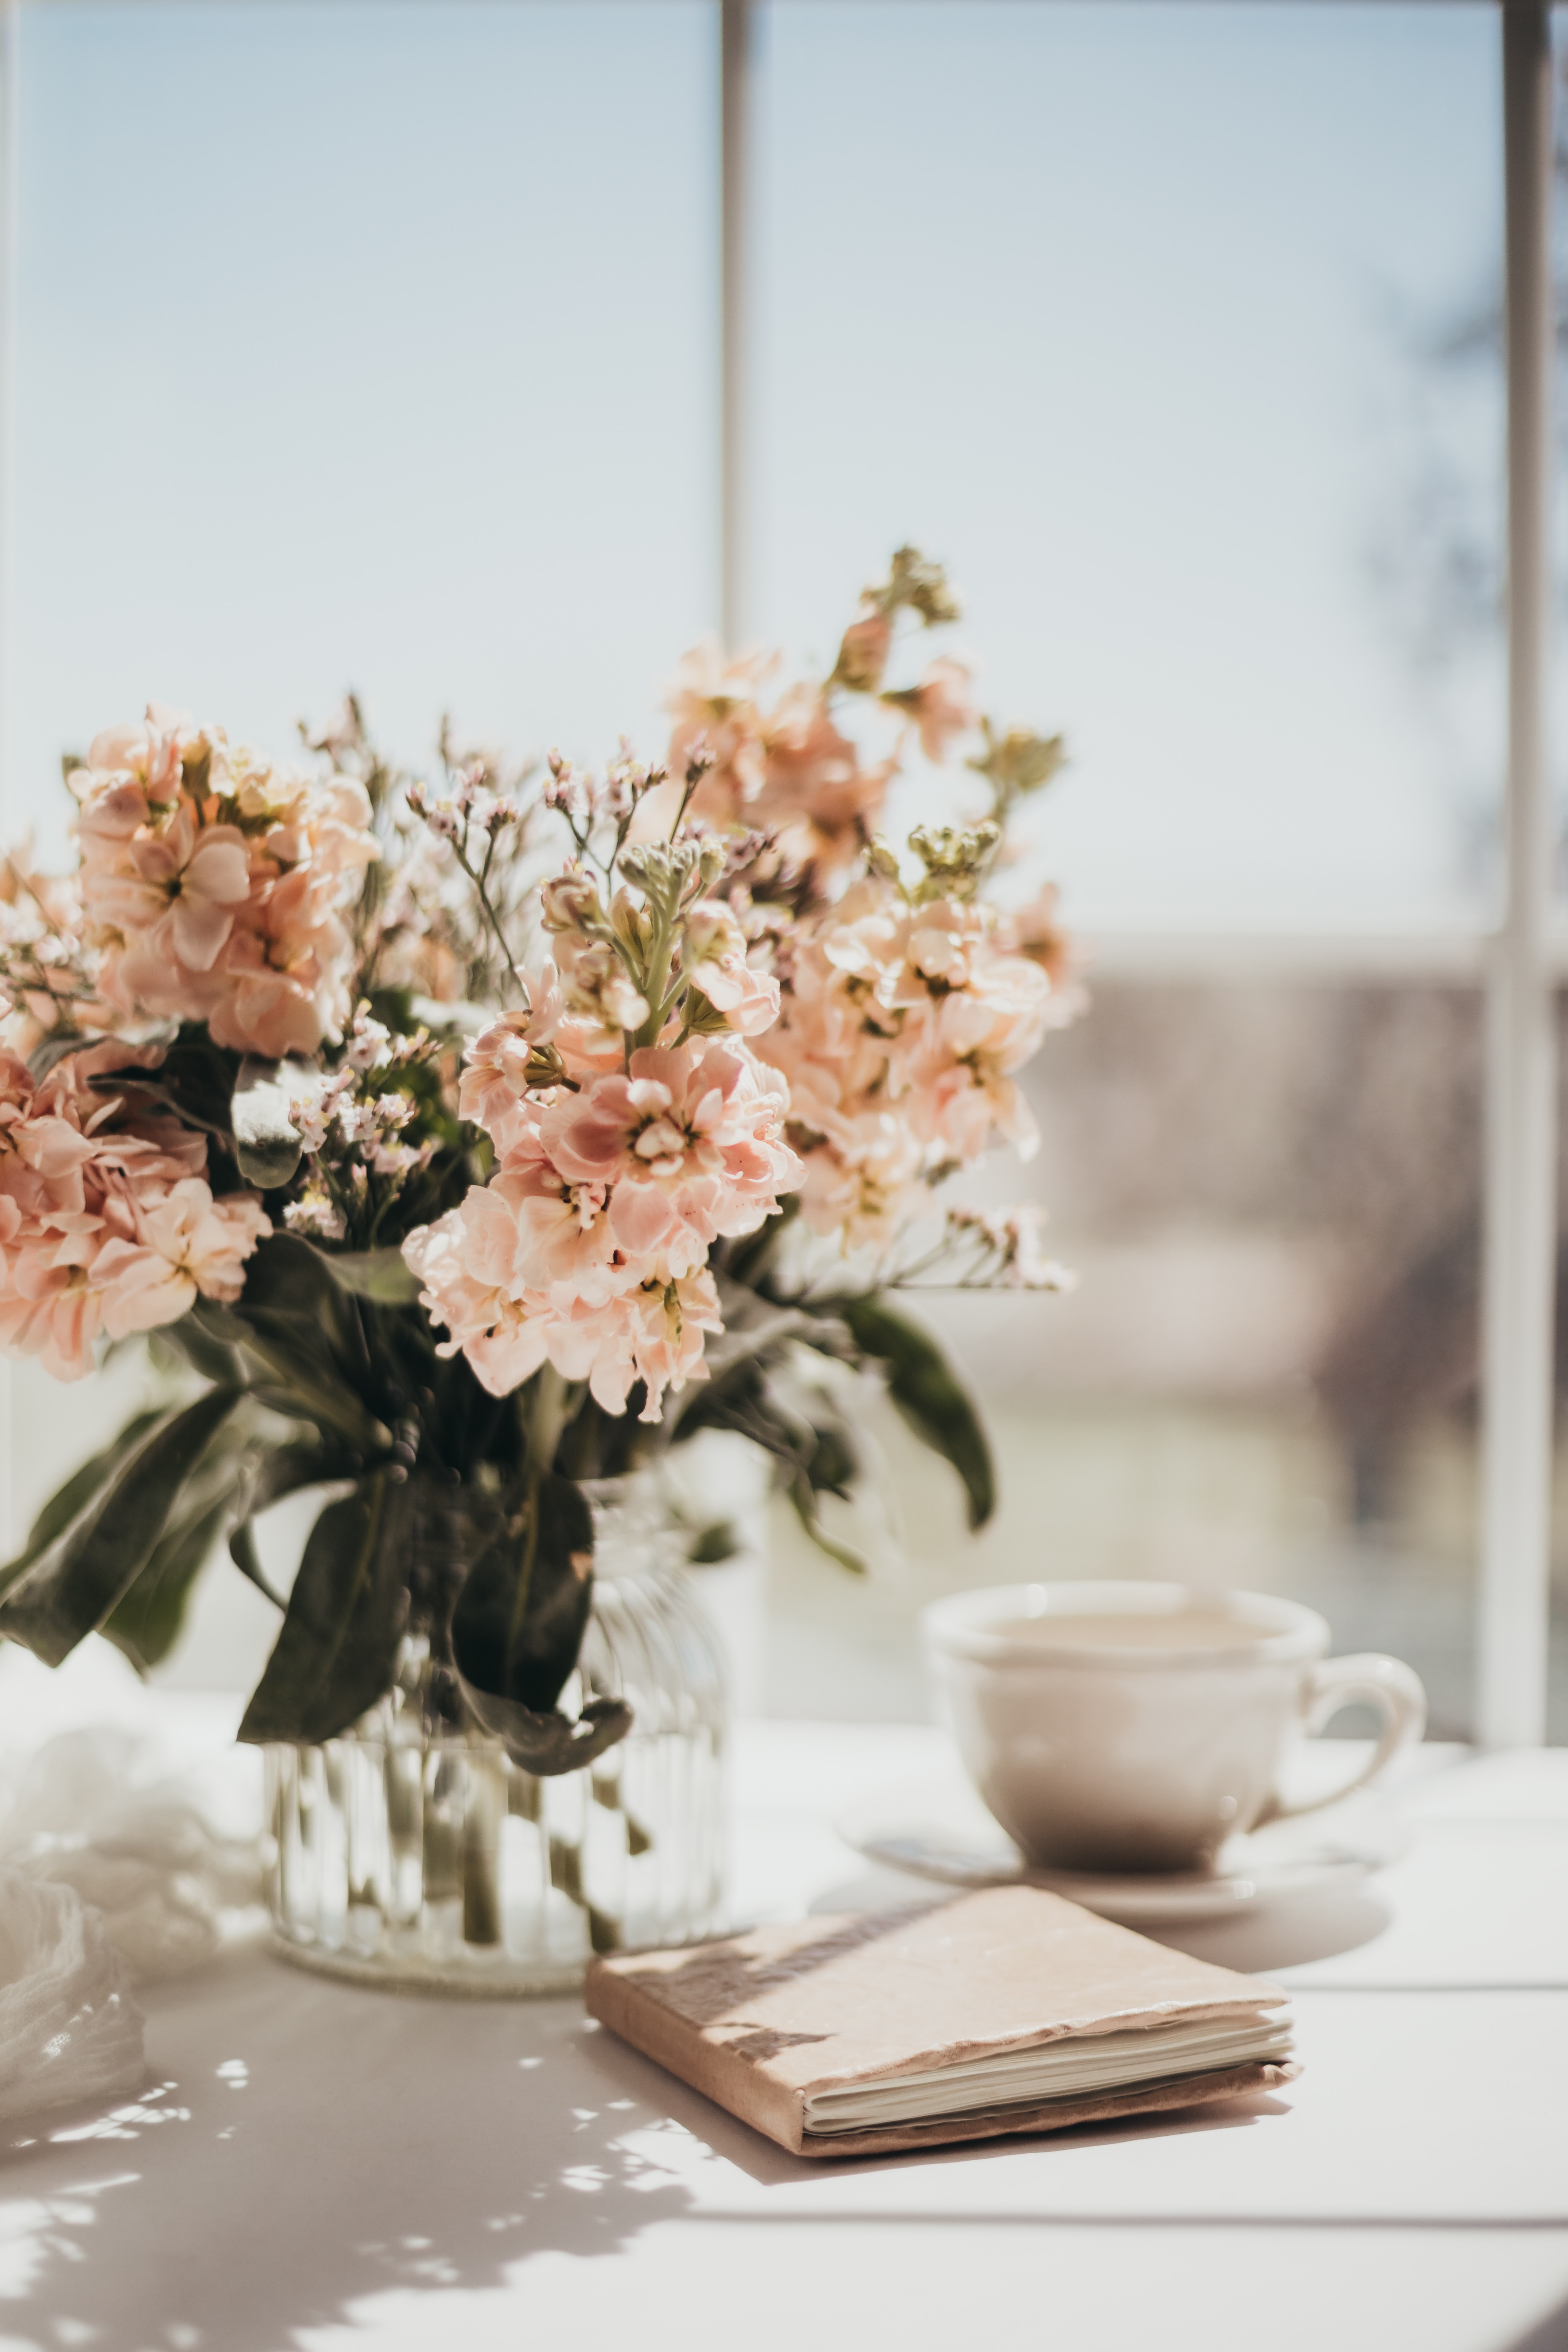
0,0,1568,1748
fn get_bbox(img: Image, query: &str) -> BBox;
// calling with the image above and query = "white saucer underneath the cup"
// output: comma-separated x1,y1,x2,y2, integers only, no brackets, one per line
837,1780,1410,1926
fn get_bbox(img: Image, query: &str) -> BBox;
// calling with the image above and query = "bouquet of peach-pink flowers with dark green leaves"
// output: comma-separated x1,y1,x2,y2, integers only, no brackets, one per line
0,548,1072,1815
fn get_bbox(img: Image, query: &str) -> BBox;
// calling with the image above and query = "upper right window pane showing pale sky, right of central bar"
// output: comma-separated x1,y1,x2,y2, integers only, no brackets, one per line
759,0,1502,927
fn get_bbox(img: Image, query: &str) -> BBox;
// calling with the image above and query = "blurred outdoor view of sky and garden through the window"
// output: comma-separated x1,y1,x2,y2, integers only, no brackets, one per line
0,0,1568,1740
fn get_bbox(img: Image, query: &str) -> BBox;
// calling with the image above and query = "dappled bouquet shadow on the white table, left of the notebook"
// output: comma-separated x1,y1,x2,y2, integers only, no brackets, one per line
0,1954,703,2352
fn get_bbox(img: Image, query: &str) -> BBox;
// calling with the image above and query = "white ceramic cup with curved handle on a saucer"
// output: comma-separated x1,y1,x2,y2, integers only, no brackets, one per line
921,1583,1427,1870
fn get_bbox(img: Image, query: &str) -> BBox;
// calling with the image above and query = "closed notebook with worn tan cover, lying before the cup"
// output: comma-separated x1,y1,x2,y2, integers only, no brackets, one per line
585,1886,1295,2157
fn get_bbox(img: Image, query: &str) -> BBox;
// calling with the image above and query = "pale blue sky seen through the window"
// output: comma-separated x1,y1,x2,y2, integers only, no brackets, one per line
5,0,1502,929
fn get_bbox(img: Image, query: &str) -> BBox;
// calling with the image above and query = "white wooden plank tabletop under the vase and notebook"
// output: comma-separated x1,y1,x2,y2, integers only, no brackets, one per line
0,1705,1568,2352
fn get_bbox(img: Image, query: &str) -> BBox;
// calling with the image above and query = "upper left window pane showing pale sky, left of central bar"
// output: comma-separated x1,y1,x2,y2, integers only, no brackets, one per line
10,0,717,846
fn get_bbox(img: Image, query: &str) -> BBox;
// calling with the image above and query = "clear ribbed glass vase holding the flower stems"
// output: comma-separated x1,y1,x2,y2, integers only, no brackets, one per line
266,1477,727,1994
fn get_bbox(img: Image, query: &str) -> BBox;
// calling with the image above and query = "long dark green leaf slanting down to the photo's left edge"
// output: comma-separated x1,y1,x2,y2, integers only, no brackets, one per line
0,1388,240,1665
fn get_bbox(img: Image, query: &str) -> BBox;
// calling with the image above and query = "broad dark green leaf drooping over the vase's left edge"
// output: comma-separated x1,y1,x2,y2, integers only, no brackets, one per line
240,1470,409,1745
